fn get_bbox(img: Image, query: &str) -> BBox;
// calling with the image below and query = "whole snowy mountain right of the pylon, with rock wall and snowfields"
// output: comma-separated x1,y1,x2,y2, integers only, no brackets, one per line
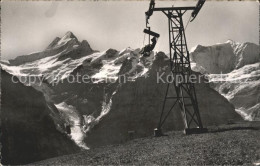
191,40,260,120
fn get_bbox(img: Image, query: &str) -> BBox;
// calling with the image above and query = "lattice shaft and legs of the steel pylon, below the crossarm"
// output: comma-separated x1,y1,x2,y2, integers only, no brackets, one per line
155,10,206,134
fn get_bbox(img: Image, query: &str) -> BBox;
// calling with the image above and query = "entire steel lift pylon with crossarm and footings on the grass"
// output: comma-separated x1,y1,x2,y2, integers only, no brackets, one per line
142,0,207,136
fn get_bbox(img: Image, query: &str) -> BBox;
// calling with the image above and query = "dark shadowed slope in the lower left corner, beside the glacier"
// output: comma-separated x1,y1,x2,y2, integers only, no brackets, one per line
1,70,79,164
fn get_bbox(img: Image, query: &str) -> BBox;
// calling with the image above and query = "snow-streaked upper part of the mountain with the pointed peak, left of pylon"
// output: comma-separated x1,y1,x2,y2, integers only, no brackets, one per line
1,32,148,83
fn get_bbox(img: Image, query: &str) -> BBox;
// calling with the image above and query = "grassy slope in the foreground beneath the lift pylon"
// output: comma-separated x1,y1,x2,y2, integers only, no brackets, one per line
36,130,260,165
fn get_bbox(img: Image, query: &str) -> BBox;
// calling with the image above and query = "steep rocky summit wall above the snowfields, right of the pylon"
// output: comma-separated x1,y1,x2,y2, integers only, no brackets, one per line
190,40,260,74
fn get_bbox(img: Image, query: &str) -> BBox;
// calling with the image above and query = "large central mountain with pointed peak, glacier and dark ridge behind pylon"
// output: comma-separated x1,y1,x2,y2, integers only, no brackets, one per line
1,32,241,156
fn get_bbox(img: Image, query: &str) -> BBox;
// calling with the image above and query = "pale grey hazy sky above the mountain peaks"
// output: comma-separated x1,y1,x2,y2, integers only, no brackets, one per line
1,1,259,59
